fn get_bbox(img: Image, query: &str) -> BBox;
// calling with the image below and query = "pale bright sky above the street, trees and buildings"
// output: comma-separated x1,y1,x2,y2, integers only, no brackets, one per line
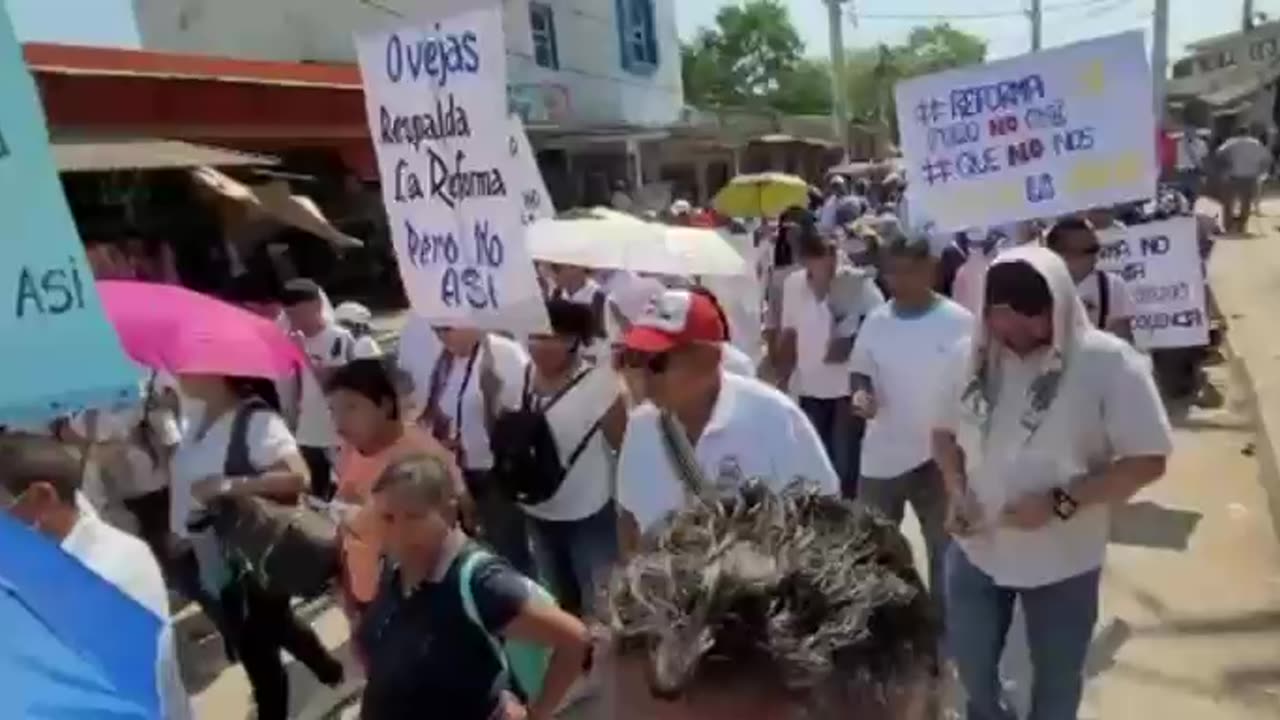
0,0,1280,59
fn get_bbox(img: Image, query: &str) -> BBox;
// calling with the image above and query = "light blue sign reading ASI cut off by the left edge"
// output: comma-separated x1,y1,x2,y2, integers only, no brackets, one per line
0,6,140,425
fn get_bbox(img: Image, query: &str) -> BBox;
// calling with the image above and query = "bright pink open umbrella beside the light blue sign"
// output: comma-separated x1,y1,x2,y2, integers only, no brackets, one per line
97,281,306,378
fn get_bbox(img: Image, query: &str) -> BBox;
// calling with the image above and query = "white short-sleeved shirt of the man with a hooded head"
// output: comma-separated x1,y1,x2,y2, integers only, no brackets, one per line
934,329,1172,588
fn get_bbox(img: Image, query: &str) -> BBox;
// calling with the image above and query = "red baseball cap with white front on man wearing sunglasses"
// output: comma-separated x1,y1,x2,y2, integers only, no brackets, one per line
622,290,728,352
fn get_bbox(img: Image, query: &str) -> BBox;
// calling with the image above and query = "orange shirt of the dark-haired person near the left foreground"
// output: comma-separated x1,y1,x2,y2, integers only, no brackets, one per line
334,425,462,603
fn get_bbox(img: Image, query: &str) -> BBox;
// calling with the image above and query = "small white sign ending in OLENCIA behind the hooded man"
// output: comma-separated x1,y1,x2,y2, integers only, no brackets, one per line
1098,218,1208,348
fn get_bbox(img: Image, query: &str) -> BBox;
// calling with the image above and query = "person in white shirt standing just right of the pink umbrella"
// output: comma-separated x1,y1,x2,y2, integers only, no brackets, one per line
283,278,356,498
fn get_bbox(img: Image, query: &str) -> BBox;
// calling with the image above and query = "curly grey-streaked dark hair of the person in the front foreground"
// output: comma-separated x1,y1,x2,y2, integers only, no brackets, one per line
602,483,937,703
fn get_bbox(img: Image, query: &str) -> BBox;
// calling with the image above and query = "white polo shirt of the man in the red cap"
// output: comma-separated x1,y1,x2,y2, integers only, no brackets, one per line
618,372,840,530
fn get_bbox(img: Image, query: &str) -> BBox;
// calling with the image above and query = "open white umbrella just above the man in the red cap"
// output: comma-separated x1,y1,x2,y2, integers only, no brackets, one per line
527,209,749,277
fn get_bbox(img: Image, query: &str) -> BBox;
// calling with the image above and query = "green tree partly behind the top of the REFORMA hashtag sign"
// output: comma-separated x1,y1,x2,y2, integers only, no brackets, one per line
845,23,987,136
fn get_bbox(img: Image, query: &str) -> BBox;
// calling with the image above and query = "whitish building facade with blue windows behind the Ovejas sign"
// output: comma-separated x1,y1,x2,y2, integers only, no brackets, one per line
134,0,684,131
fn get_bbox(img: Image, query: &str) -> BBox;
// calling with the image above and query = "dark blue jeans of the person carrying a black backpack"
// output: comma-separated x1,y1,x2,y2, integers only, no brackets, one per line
529,501,618,609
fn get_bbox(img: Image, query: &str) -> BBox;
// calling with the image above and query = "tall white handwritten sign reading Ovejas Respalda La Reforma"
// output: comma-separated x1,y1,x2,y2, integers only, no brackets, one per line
356,5,548,333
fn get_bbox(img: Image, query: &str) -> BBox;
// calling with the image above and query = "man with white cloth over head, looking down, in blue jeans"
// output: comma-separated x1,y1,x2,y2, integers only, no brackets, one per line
933,247,1172,720
